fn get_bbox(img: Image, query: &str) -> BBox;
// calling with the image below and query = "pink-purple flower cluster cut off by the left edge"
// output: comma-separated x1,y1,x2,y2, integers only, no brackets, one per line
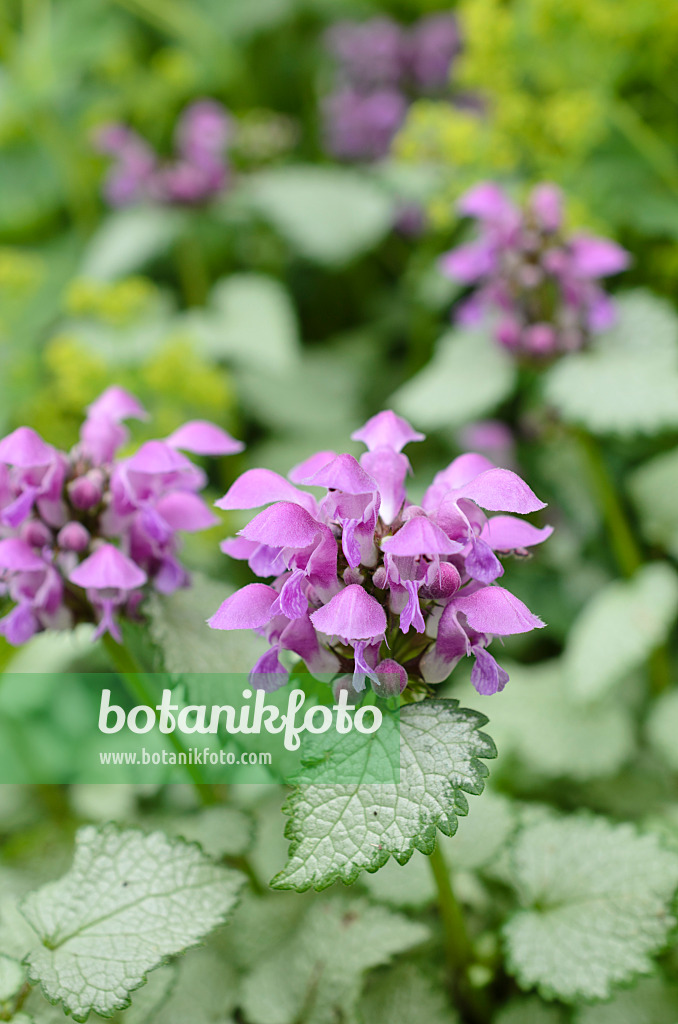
0,387,243,645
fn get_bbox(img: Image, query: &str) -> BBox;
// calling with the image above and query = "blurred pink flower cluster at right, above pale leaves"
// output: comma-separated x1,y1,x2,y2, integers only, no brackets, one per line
440,183,629,358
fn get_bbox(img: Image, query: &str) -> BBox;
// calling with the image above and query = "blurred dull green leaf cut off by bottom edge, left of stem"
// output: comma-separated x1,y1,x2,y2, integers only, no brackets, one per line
361,964,458,1024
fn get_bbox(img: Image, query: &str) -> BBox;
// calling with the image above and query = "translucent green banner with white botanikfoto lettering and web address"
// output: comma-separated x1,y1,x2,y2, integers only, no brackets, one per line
0,672,400,784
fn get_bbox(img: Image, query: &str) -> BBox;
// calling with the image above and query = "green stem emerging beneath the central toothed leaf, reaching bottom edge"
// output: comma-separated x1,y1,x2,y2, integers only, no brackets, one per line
428,844,491,1024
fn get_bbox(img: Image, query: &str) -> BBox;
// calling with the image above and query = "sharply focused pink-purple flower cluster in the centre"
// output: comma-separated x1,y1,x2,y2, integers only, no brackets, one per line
209,412,552,694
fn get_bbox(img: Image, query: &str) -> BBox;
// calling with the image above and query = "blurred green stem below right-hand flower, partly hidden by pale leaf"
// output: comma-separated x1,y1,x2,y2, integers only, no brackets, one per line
579,431,671,693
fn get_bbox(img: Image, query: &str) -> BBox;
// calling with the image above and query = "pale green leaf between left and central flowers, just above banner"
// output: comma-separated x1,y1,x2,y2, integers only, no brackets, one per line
144,572,266,673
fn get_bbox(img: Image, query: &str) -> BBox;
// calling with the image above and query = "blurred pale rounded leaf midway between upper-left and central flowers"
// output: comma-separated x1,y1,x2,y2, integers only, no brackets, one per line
196,273,300,374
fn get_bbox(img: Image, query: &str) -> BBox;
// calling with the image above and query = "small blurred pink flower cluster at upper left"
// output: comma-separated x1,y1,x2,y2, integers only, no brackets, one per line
96,99,231,206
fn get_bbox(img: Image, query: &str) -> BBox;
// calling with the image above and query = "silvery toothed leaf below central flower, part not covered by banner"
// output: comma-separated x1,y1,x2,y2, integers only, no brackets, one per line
271,699,496,890
